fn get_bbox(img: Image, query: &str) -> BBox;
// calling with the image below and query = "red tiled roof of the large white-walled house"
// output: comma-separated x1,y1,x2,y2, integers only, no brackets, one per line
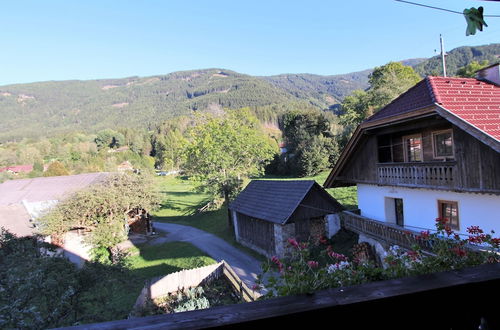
367,76,500,141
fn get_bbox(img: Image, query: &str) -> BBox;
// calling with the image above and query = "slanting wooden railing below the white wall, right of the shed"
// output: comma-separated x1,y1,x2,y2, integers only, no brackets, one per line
341,211,432,251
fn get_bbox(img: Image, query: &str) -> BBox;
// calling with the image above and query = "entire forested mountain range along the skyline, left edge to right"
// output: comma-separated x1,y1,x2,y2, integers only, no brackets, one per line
0,44,500,142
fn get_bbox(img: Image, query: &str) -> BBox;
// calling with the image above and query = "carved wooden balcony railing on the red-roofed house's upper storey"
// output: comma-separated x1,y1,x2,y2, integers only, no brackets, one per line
377,162,457,188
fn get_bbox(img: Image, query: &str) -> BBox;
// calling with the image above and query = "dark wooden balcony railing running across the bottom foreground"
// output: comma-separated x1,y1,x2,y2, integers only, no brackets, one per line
63,264,500,329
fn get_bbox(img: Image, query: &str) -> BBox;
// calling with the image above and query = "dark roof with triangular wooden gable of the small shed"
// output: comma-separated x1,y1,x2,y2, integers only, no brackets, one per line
229,180,343,224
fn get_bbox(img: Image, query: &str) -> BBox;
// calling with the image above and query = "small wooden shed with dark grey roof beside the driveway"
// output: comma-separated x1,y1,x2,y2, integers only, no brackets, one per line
229,180,343,257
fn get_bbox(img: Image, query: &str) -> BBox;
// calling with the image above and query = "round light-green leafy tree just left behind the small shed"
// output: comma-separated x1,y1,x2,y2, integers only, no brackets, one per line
185,110,277,208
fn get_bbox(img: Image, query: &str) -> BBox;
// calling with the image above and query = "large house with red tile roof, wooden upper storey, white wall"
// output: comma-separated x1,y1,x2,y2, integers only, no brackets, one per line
324,64,500,242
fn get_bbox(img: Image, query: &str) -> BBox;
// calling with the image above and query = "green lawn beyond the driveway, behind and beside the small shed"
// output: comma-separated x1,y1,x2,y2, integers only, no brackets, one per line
153,172,357,261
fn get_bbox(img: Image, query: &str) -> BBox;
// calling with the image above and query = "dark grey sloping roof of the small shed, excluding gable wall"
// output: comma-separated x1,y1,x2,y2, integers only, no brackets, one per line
229,180,341,224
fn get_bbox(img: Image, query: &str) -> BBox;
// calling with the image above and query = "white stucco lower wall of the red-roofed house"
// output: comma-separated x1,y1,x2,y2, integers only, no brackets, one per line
358,184,500,236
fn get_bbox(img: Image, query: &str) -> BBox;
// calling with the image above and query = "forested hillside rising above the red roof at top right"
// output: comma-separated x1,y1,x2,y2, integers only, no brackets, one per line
413,44,500,76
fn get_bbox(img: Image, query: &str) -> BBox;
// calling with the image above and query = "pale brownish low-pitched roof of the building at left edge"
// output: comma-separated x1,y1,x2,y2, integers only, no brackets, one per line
0,172,109,206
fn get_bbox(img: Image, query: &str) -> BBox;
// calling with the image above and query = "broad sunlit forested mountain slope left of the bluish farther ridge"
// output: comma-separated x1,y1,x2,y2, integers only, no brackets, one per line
0,69,304,141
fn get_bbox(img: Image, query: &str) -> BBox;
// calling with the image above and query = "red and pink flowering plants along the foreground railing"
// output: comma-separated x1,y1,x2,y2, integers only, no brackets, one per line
259,218,500,297
